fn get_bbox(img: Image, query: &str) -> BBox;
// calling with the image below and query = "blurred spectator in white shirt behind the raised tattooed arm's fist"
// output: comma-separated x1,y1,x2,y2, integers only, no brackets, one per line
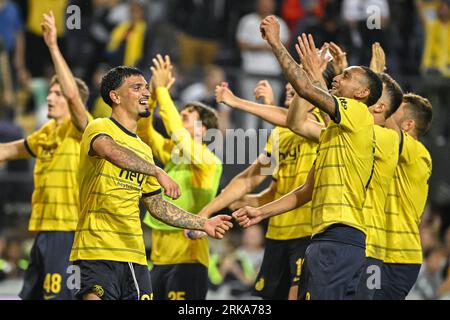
236,0,289,129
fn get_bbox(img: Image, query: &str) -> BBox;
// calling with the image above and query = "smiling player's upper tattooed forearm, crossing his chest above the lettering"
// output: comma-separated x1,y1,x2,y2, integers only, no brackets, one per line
97,136,157,176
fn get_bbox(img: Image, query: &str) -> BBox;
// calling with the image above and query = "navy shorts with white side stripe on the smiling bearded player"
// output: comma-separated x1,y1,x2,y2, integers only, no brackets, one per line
74,260,153,300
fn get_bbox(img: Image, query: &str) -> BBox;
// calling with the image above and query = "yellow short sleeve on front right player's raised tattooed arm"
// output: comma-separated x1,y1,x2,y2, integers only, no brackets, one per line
332,97,373,132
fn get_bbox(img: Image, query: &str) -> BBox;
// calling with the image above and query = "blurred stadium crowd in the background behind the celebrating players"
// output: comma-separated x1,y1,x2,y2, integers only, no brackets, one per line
0,0,450,299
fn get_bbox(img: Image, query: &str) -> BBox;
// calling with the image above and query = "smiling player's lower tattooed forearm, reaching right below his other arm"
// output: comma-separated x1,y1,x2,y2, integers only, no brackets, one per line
144,194,206,230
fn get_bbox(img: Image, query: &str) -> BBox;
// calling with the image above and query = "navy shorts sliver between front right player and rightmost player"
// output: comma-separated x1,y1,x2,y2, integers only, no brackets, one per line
355,257,383,300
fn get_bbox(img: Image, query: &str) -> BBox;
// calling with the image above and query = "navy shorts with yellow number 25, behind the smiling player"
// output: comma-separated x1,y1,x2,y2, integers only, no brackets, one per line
150,263,208,300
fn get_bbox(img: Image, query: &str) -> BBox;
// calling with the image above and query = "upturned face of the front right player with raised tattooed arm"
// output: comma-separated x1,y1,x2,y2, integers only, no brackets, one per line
331,67,365,99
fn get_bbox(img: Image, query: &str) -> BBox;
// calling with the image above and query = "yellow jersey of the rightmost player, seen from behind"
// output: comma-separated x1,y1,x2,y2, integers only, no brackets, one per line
385,132,432,264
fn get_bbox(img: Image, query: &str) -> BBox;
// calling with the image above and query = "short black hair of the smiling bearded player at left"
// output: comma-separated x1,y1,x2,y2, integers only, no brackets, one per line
100,66,144,107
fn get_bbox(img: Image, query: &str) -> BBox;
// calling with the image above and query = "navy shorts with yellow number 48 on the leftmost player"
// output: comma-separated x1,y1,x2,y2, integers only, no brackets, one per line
19,231,75,300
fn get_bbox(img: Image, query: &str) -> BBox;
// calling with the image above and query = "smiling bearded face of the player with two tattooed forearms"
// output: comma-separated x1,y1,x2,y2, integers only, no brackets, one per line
116,75,150,118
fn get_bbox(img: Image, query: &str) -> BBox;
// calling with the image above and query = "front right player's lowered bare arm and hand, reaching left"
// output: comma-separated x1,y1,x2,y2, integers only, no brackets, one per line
233,166,315,228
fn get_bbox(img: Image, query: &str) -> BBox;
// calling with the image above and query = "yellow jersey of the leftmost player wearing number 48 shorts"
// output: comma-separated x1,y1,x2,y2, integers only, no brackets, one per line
25,115,92,231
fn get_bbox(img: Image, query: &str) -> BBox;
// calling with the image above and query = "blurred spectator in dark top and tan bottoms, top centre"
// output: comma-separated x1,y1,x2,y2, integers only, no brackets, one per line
174,0,227,72
